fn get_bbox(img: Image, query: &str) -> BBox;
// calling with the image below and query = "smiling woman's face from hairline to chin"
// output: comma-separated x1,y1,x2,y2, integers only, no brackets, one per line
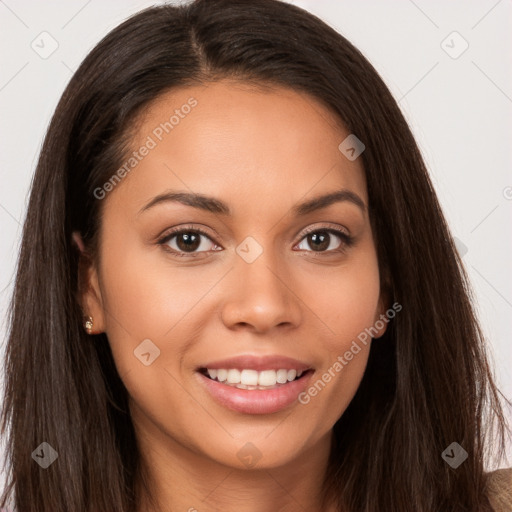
78,81,386,468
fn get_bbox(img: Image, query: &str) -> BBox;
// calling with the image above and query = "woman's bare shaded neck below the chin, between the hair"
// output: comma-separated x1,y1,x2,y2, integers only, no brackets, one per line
132,410,335,512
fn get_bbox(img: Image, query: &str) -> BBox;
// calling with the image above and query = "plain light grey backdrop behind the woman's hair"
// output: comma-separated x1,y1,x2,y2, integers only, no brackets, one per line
0,0,512,488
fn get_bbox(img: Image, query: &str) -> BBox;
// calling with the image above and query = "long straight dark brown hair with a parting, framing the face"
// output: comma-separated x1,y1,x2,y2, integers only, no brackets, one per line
1,0,507,512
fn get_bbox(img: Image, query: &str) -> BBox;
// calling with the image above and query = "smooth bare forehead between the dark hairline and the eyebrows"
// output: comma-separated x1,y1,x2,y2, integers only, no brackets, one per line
106,80,367,213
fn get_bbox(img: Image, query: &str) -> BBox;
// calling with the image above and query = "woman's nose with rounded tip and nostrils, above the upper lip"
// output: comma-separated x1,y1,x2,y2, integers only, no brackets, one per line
221,251,302,333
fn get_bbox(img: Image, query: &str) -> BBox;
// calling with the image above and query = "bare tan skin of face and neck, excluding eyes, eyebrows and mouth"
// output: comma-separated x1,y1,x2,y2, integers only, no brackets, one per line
76,80,387,512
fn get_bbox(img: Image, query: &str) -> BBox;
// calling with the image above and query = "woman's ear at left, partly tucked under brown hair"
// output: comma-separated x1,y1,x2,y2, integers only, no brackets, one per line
72,231,105,334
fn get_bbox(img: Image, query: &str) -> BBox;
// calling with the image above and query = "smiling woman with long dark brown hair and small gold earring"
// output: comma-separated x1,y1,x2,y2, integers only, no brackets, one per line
3,0,512,512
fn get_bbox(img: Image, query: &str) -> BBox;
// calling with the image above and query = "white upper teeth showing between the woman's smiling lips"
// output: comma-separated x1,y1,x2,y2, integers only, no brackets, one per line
199,368,312,391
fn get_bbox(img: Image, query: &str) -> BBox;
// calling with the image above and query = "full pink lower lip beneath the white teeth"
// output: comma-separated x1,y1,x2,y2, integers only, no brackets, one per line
197,371,313,414
